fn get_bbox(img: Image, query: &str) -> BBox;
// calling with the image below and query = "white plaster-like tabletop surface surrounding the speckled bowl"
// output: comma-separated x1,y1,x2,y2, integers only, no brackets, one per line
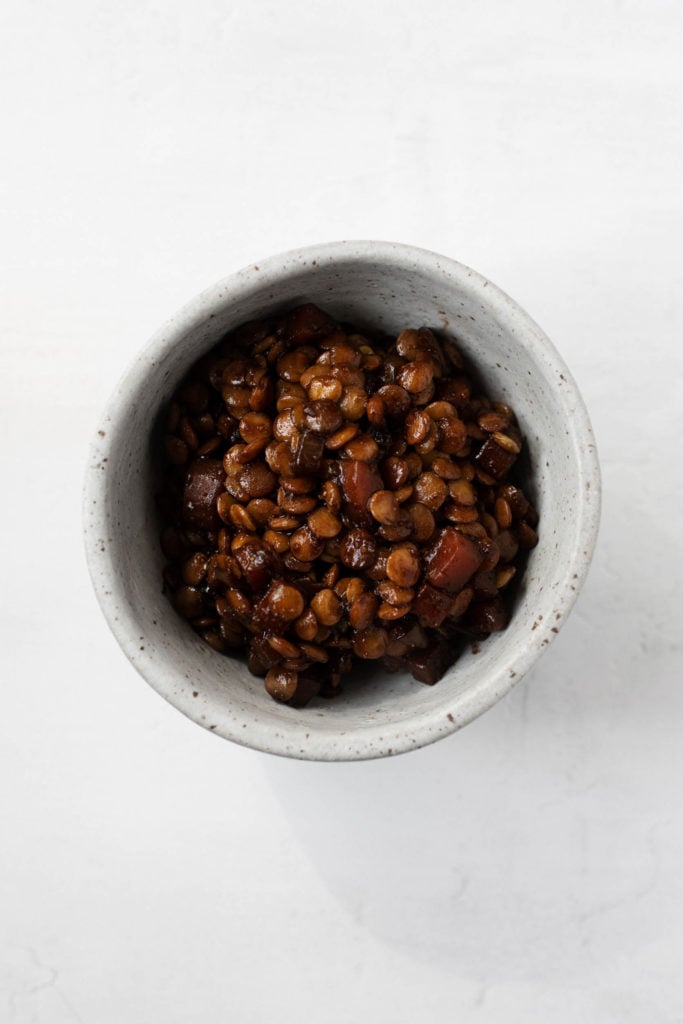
0,0,683,1024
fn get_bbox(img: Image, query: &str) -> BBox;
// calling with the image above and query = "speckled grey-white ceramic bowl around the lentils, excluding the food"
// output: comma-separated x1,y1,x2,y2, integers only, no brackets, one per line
85,242,600,761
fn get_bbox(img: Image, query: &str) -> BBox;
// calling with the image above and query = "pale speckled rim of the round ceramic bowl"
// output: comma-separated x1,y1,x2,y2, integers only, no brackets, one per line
83,240,601,761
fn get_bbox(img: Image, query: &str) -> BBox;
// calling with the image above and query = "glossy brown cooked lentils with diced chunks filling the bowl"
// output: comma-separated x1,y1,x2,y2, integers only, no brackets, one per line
160,304,538,707
